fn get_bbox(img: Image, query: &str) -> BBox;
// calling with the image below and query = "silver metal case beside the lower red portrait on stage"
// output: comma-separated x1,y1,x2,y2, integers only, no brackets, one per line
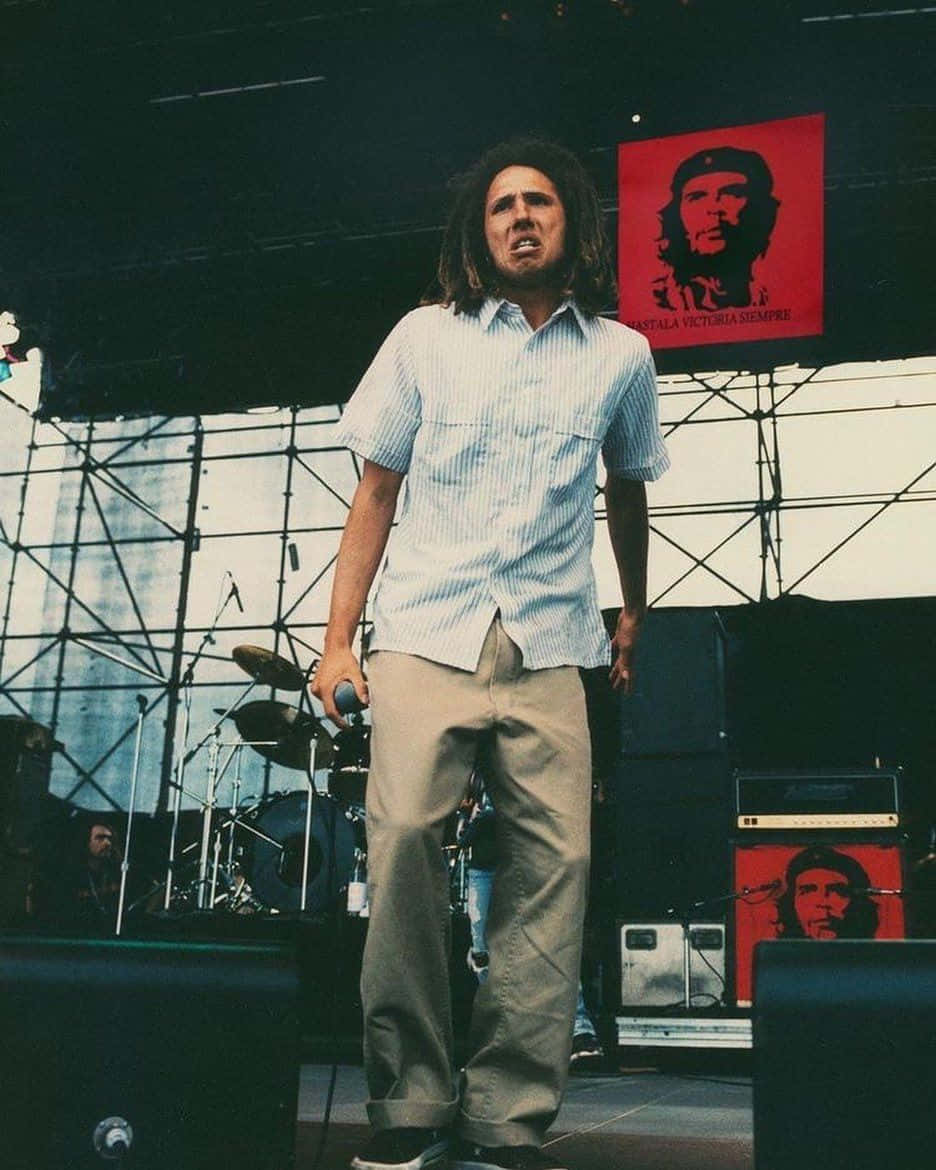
619,921,725,1007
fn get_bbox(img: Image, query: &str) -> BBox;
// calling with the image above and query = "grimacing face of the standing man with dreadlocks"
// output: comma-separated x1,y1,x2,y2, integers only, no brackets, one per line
484,166,565,289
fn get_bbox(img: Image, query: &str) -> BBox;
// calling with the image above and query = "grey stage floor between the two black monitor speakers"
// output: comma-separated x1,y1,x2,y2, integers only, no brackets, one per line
297,1062,753,1170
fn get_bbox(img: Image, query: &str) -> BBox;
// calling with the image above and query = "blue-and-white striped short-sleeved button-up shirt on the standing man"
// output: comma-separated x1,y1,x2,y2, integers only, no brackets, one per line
337,298,669,670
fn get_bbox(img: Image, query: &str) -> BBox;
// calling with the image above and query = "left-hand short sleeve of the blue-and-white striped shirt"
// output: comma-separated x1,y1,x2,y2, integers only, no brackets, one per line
335,316,421,474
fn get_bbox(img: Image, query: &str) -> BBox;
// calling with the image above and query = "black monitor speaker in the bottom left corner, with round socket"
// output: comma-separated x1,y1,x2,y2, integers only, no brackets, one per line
0,937,300,1170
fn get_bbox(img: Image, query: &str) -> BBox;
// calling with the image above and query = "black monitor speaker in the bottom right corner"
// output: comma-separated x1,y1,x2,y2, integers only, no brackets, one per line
753,940,936,1170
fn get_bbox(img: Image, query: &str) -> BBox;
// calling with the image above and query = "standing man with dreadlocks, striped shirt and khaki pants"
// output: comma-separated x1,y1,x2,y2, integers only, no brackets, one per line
312,140,668,1170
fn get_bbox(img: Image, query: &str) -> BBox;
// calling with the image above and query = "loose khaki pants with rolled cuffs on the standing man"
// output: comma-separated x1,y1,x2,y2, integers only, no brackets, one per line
362,619,591,1145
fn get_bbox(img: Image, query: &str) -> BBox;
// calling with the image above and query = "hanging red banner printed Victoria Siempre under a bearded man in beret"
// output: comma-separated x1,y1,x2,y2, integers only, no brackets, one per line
618,113,825,349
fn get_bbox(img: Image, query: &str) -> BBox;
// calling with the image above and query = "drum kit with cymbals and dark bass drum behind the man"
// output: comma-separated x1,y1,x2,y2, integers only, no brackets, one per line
156,645,467,917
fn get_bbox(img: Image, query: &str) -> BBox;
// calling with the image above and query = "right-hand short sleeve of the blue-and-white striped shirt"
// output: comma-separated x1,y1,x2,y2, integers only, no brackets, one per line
601,338,669,480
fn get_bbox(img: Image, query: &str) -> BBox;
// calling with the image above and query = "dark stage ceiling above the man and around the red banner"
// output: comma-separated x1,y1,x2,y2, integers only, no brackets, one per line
0,0,936,415
